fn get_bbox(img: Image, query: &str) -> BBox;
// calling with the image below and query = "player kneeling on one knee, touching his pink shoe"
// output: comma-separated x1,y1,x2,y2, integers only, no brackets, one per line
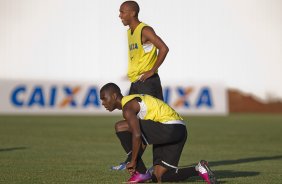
100,83,216,184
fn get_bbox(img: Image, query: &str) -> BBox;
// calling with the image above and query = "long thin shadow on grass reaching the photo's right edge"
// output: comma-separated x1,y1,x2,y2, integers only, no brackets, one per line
209,155,282,166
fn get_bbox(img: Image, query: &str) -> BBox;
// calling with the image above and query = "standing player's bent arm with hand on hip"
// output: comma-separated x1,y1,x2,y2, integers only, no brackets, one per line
139,26,169,82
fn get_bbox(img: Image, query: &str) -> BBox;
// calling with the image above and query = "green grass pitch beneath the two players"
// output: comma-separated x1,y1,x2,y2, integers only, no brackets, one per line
0,114,282,184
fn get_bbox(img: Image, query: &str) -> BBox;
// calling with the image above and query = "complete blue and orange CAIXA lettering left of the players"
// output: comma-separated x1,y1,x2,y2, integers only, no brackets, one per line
11,85,101,108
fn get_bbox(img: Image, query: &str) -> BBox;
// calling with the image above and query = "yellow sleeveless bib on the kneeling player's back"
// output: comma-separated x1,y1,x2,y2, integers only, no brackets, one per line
121,94,185,124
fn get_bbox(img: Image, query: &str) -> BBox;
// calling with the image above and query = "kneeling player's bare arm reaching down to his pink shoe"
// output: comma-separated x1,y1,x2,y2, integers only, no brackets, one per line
123,99,142,175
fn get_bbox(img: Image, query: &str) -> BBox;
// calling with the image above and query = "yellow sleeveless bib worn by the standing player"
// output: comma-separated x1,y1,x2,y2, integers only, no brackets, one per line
127,22,157,82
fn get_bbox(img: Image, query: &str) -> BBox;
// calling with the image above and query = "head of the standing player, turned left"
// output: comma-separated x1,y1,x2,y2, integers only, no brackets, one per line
119,1,140,26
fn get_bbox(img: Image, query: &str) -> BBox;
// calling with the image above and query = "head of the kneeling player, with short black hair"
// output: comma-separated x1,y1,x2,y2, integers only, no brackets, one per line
100,83,122,112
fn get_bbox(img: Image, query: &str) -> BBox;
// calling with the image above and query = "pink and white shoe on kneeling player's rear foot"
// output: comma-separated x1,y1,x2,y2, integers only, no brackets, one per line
196,160,216,184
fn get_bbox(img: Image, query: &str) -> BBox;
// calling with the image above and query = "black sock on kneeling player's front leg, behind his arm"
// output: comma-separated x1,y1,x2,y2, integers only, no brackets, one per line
116,131,147,173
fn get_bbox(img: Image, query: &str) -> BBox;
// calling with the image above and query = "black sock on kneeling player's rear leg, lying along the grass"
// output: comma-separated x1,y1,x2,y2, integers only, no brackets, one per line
152,167,198,182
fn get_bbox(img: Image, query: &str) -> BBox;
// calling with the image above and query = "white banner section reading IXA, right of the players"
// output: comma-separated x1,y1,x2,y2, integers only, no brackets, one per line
163,82,228,115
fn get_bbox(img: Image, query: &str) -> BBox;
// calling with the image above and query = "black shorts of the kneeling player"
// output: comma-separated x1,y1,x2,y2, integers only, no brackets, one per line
140,120,187,169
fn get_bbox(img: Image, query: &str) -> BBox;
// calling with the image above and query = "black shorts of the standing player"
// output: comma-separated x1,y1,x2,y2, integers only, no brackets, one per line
129,73,164,100
